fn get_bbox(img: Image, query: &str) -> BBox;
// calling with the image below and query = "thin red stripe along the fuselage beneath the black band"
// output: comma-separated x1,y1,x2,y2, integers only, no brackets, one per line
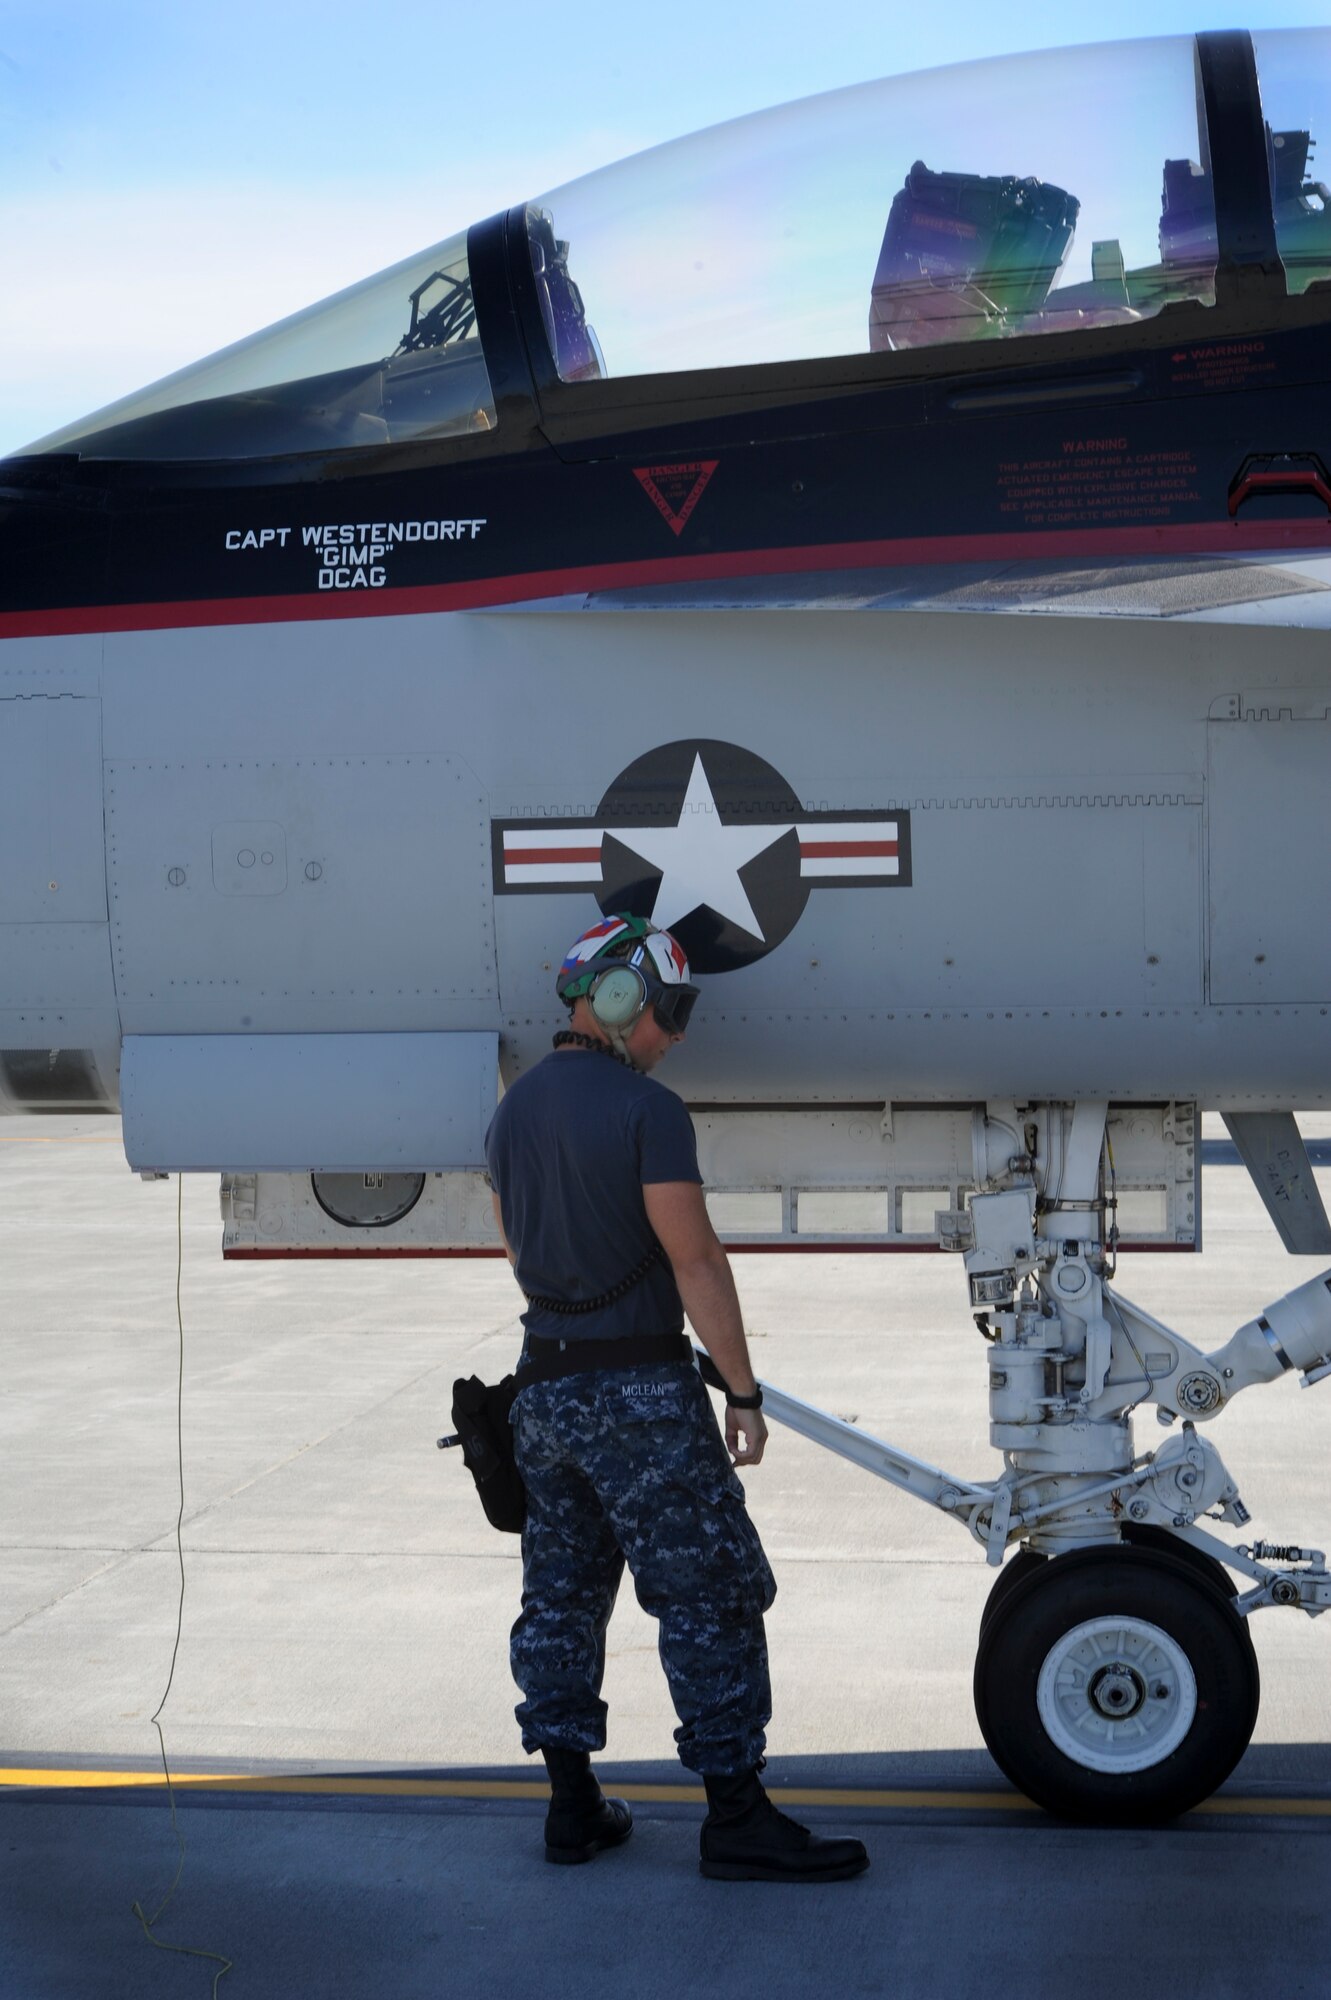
0,520,1331,638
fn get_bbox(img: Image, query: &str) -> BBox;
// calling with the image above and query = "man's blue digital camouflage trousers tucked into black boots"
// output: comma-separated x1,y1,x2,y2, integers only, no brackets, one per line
512,1362,775,1776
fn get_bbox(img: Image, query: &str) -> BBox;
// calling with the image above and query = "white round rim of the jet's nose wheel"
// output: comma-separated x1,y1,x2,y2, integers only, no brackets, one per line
1035,1614,1197,1776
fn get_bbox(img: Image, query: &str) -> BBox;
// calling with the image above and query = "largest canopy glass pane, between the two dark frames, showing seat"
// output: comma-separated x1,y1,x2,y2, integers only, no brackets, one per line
530,36,1215,380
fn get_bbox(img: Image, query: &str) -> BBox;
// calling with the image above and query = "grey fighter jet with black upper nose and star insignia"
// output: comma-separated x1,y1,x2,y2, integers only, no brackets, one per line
0,30,1331,1818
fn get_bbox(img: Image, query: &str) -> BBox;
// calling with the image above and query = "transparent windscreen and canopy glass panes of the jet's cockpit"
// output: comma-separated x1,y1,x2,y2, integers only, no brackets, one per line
30,30,1331,460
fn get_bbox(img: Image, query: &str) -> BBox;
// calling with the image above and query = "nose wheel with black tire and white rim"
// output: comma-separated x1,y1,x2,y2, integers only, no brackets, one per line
975,1546,1261,1826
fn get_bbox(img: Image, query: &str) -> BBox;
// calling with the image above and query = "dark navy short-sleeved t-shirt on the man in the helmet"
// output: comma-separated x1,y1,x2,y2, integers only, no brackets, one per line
486,1048,701,1340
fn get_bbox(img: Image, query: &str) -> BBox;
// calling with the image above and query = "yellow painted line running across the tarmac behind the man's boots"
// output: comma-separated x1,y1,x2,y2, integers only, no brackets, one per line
0,1768,1331,1820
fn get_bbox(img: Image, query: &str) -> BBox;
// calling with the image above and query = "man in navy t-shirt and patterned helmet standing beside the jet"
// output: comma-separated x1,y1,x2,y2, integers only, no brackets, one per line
486,916,869,1882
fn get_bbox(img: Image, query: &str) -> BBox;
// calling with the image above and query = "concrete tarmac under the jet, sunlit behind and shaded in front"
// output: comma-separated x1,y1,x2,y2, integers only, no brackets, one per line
0,1118,1331,2000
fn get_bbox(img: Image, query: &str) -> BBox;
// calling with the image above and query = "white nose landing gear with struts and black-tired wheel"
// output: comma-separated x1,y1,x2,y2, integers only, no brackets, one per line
695,1102,1331,1824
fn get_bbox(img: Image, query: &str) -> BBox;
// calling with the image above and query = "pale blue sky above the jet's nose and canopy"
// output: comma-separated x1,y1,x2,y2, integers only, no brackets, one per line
0,0,1331,452
